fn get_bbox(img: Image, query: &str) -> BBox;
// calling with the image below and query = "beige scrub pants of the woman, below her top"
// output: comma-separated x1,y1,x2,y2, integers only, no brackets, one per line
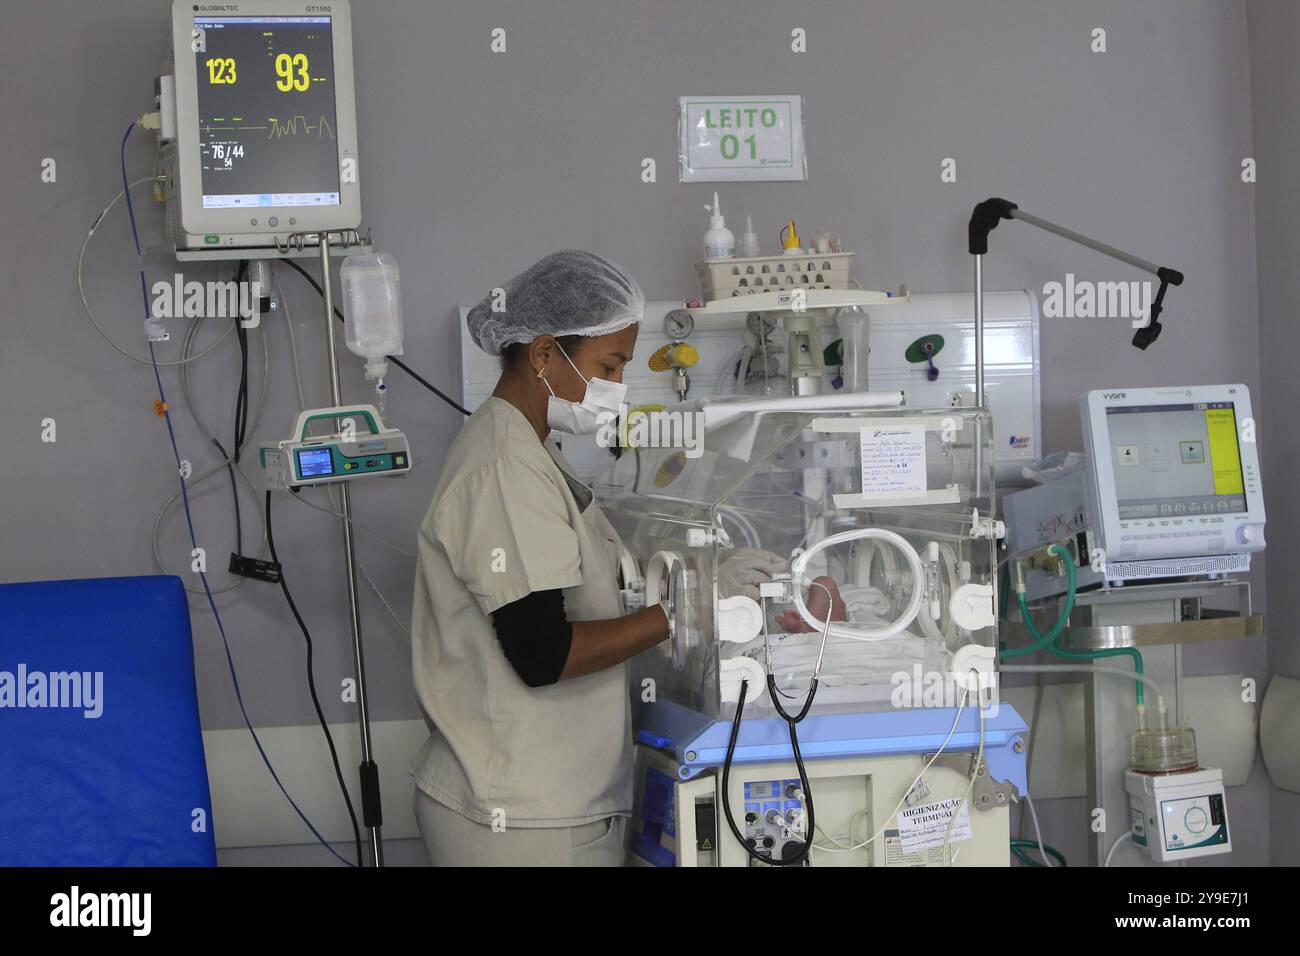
415,787,628,866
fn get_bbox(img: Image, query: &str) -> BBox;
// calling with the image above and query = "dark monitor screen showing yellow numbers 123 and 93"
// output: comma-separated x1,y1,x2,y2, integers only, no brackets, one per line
194,17,339,209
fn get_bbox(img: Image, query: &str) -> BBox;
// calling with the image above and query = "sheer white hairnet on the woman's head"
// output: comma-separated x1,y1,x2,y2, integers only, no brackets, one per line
465,250,646,355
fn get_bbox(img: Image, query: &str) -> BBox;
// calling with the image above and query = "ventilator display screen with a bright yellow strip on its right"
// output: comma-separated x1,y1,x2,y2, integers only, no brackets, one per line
1106,402,1245,520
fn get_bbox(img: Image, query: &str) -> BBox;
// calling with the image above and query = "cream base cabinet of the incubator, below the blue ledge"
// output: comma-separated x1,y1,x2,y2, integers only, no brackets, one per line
627,706,1026,866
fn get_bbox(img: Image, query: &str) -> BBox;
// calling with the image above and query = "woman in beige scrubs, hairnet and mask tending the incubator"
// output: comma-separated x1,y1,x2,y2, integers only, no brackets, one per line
411,251,668,866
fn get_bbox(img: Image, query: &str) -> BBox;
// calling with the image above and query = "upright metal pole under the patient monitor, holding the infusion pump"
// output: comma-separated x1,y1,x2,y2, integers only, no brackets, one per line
320,232,384,866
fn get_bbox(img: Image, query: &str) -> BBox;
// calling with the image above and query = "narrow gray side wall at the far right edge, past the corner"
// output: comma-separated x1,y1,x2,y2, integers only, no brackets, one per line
1247,0,1300,866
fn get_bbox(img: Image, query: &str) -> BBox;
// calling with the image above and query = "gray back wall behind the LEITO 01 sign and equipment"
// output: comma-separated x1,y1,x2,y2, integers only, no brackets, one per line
0,0,1279,862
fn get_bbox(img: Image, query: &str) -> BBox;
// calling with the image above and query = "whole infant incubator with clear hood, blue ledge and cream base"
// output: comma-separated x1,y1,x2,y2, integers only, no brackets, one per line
593,393,1026,865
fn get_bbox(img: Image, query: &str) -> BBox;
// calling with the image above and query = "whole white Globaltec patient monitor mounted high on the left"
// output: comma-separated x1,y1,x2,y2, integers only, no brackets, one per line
159,0,361,250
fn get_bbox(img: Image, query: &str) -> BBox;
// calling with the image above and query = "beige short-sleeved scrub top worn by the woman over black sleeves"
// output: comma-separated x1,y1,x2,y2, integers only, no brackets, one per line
411,397,632,827
